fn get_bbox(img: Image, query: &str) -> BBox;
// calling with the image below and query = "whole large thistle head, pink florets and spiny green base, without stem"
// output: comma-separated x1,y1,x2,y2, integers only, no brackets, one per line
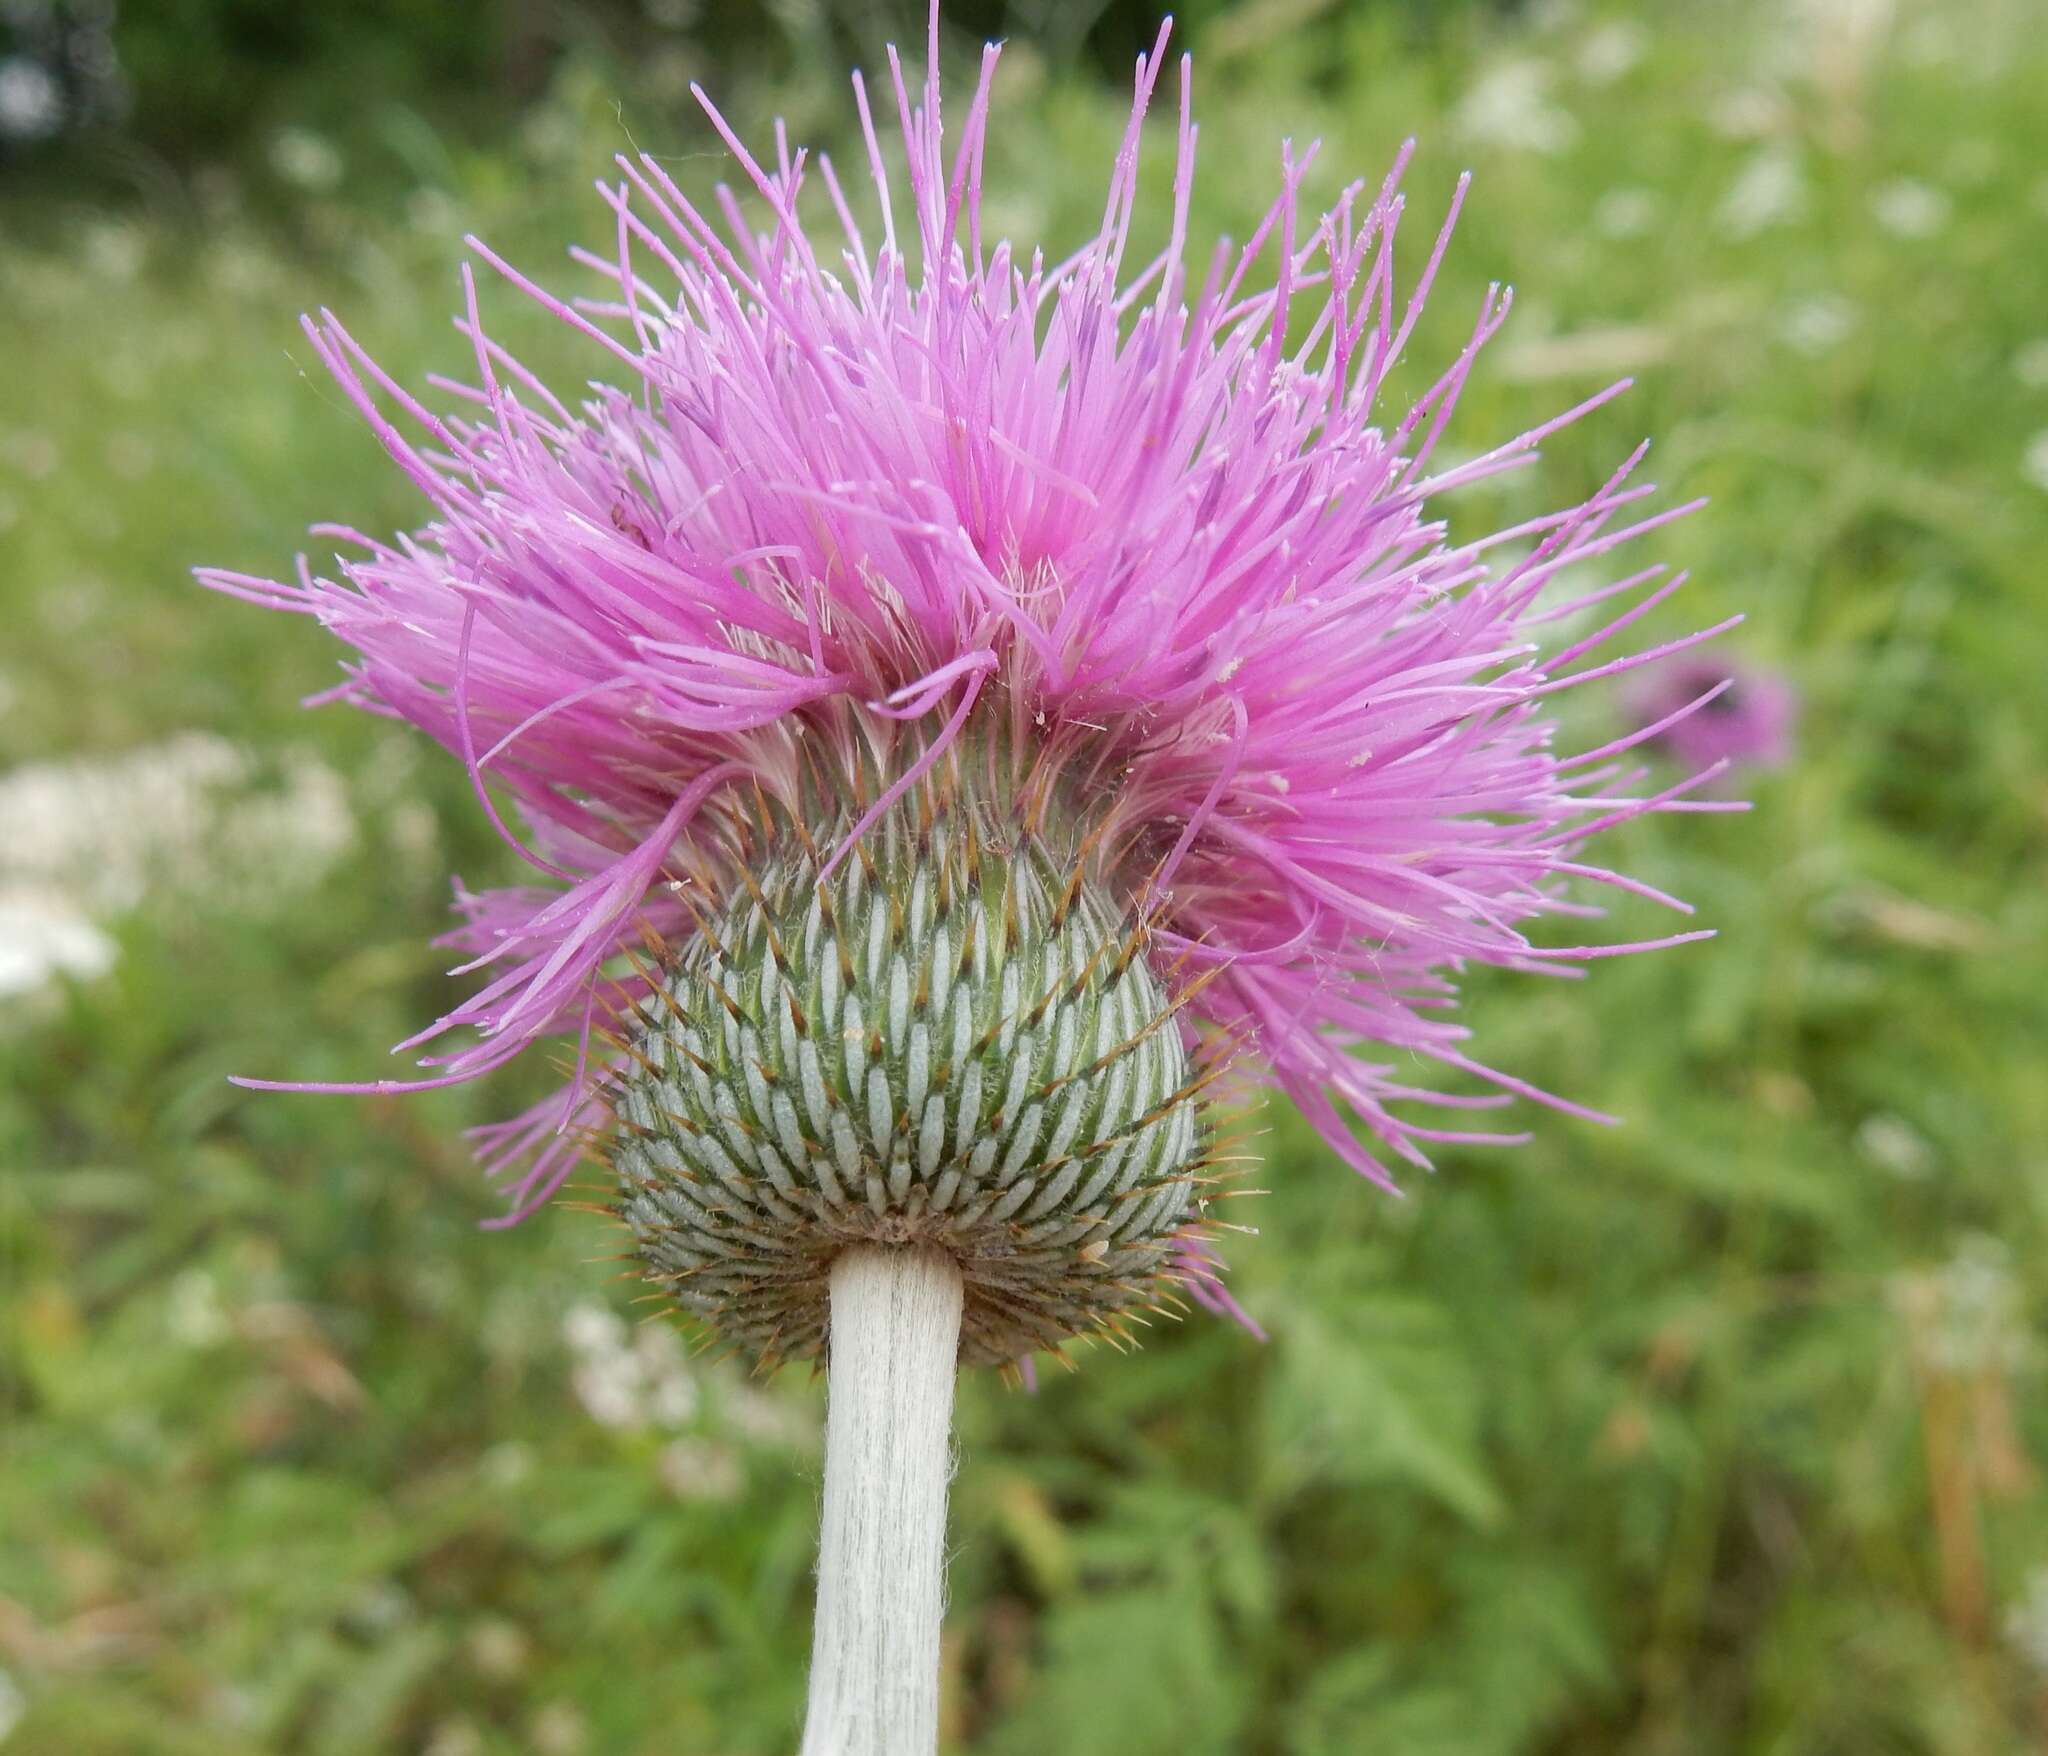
203,16,1726,1358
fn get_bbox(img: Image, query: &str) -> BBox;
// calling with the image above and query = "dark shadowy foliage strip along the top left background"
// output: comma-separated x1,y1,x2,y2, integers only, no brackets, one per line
0,0,1516,186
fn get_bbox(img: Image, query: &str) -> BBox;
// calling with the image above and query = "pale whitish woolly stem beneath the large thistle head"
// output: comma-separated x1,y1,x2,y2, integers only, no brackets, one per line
801,1246,961,1756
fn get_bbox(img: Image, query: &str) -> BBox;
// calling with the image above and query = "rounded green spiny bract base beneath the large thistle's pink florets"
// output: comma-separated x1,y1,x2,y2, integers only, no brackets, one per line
610,745,1202,1365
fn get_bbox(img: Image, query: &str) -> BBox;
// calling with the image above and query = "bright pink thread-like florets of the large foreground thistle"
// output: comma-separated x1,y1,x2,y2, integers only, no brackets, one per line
201,8,1731,1229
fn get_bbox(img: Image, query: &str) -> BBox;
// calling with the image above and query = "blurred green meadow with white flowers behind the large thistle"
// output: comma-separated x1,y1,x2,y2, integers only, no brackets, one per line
0,0,2048,1756
